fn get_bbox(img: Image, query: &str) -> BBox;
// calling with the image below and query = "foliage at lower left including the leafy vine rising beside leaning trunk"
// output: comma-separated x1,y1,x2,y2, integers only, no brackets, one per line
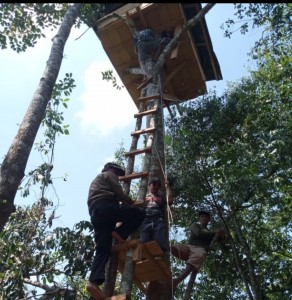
0,70,80,299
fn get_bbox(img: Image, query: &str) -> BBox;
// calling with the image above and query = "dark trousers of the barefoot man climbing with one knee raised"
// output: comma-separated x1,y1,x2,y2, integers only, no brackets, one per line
89,201,145,285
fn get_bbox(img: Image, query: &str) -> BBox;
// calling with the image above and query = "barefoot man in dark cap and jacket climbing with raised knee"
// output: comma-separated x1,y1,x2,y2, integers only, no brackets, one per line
86,163,145,300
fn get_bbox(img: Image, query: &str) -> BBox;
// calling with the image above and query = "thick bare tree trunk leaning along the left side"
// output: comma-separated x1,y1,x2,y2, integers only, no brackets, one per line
0,3,82,231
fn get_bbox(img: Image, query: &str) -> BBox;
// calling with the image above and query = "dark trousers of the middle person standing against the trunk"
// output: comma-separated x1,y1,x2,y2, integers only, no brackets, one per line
140,217,169,252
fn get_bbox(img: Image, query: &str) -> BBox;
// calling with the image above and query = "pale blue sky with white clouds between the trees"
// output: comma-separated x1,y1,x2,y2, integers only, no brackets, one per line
0,4,259,229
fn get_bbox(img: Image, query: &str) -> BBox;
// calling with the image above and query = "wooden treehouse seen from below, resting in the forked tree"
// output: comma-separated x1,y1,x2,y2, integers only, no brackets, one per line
94,3,222,107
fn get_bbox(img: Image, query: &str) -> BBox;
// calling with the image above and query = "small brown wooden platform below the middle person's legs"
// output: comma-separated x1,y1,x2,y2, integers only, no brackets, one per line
118,240,172,292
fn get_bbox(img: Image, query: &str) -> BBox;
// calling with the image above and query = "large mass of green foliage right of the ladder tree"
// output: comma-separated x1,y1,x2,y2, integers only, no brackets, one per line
167,28,292,299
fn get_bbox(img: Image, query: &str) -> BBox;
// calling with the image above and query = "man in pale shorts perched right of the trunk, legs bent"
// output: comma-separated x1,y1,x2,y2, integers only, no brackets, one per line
171,211,225,289
